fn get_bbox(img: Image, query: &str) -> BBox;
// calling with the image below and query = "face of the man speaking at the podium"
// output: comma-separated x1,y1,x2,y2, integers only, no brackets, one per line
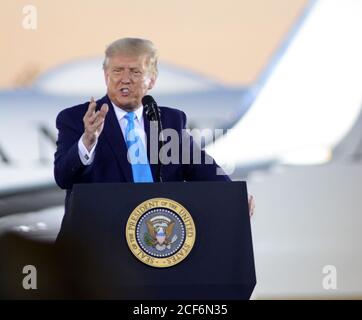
104,54,156,111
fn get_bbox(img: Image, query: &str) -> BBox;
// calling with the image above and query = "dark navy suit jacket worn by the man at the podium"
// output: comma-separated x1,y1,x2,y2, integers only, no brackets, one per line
54,96,230,240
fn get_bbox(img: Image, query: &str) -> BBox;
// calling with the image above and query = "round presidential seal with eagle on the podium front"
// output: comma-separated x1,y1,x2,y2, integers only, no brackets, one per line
126,198,196,268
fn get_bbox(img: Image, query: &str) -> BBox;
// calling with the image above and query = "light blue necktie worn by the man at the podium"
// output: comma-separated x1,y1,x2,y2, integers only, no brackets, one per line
124,112,153,182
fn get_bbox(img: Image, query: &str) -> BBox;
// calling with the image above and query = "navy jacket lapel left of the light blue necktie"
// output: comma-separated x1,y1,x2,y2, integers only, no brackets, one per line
101,96,133,182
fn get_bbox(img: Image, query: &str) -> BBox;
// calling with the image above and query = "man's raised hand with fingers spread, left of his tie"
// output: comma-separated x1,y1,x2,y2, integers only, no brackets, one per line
82,97,108,151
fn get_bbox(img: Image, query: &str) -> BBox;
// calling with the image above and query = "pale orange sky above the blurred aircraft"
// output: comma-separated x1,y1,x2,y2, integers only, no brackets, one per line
0,0,307,88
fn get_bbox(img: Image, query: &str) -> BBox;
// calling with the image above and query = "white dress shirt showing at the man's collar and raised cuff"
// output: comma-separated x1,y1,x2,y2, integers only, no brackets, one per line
78,103,147,166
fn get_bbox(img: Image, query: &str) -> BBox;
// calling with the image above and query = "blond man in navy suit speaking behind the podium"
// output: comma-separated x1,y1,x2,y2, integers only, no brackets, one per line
54,38,255,240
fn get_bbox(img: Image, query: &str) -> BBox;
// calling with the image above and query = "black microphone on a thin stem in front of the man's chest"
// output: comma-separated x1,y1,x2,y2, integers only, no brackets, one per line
142,95,164,182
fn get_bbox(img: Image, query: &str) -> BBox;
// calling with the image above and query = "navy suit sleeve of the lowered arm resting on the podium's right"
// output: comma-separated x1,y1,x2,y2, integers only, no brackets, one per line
181,112,231,181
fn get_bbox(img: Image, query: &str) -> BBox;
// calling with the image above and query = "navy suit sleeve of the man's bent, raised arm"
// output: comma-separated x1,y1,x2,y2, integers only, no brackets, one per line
54,110,86,189
